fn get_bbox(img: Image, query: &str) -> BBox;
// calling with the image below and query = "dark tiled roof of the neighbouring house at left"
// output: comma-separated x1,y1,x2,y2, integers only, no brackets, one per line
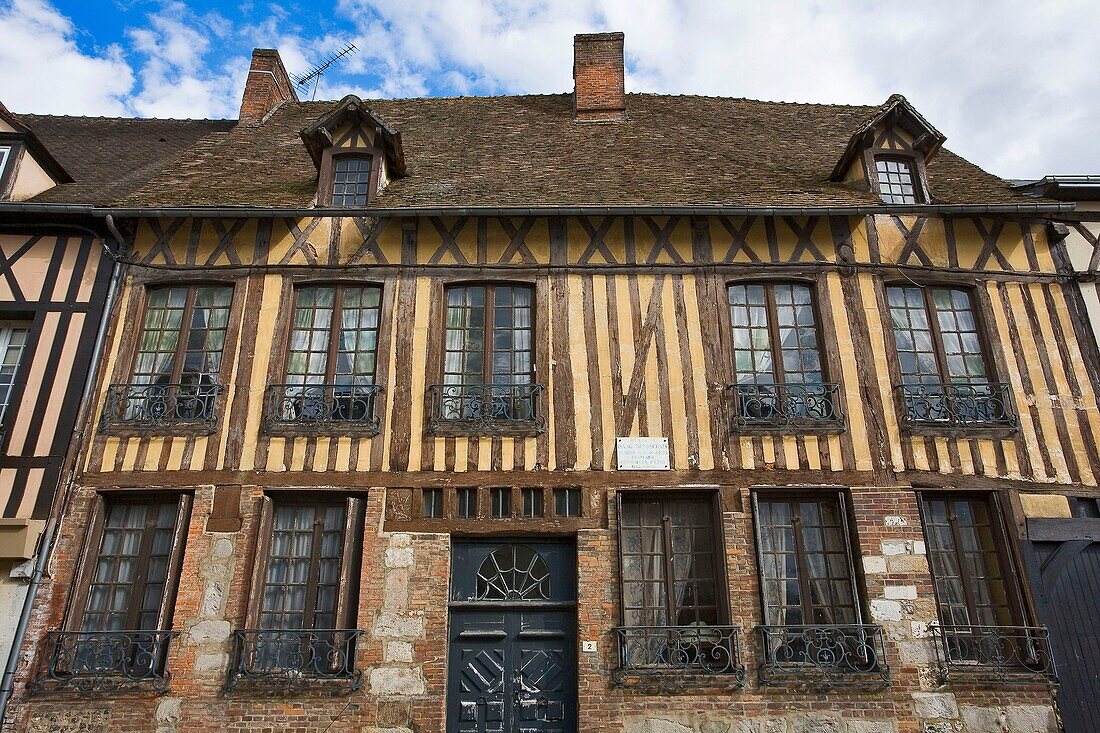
19,114,235,205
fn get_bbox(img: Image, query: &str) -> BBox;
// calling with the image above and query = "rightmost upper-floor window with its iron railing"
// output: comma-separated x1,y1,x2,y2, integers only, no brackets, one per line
887,285,1012,425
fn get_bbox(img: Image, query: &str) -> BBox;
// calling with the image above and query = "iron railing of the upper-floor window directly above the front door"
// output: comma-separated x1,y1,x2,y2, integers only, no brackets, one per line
428,384,546,435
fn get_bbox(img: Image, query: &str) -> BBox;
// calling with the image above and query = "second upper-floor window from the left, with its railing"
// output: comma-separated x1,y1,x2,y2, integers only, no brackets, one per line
267,285,382,430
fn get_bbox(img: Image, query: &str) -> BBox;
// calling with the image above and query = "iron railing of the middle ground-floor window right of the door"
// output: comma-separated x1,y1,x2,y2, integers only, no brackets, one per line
758,624,890,688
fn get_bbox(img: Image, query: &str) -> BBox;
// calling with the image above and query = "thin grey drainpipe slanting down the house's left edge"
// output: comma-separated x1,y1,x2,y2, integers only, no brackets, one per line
0,215,125,717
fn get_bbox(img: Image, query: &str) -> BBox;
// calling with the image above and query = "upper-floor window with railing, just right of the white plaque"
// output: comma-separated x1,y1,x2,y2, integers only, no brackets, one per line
728,283,839,427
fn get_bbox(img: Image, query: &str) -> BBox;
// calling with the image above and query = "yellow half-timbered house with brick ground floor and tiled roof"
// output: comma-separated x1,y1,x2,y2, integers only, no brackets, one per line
0,34,1100,733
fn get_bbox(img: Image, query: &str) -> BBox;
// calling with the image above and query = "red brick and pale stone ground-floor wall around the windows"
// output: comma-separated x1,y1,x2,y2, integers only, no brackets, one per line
6,486,1057,733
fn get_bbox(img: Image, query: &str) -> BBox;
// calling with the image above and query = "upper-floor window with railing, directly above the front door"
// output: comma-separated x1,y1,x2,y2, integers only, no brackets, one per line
431,285,541,430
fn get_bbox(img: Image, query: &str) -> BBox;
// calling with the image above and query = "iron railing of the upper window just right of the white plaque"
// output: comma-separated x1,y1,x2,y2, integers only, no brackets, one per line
728,383,844,429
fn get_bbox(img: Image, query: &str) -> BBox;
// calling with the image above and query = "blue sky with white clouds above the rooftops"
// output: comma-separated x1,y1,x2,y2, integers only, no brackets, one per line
0,0,1100,177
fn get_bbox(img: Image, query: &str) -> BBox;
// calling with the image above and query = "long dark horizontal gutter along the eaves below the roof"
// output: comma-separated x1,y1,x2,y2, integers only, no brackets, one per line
0,201,1075,219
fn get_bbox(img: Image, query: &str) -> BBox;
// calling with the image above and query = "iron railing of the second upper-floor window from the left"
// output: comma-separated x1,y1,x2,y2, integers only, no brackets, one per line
265,384,385,435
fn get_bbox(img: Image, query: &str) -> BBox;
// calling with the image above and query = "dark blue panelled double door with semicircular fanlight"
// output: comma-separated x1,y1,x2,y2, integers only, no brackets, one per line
447,540,576,733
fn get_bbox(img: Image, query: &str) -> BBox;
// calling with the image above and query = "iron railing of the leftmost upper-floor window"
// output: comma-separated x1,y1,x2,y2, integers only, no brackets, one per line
99,383,224,430
